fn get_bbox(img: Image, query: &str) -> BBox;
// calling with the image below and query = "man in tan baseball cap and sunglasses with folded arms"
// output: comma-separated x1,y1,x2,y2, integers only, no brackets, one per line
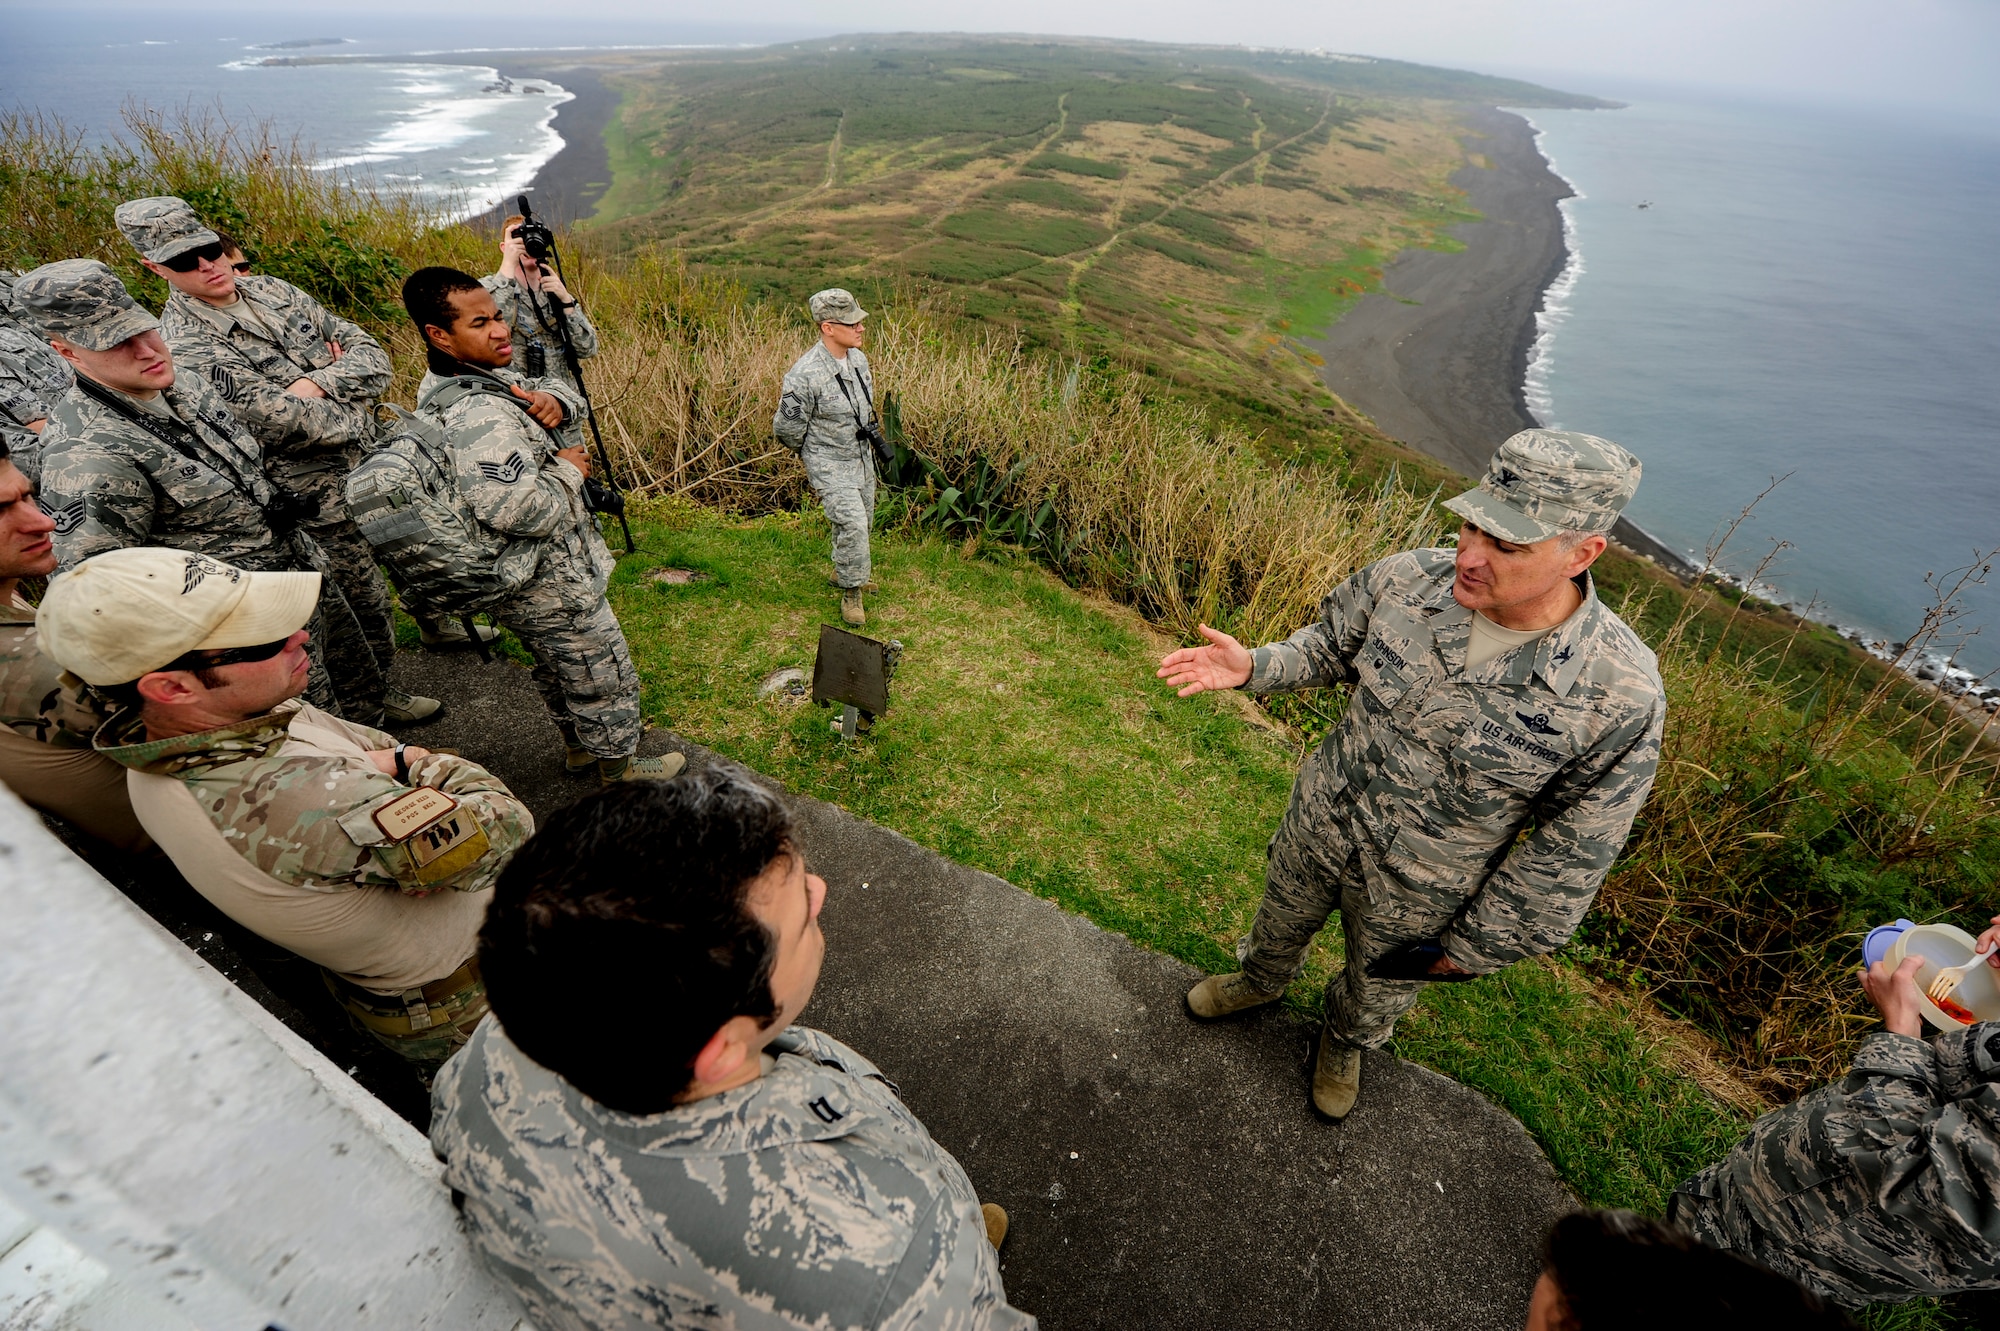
36,546,534,1063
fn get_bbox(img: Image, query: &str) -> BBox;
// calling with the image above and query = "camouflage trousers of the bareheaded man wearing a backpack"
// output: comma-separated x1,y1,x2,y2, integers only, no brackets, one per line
490,574,640,757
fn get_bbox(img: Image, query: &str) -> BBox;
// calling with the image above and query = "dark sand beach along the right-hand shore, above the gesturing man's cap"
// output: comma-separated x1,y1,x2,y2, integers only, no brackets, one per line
1314,108,1692,574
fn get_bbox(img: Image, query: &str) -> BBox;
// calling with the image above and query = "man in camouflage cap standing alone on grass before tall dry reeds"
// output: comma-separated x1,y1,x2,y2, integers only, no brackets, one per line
770,286,882,628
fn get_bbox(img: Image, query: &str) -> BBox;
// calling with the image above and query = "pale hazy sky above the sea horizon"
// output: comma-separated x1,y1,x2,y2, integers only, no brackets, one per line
15,0,2000,118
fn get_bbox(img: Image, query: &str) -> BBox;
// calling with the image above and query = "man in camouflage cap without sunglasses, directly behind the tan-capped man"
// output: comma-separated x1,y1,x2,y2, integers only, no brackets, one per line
14,260,360,711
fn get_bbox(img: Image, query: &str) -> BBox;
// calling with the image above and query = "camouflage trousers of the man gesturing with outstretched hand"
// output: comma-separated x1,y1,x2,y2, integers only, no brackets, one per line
1244,779,1458,1049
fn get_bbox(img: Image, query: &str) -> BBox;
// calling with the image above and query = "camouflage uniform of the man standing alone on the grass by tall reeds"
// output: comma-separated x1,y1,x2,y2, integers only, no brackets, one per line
770,323,876,588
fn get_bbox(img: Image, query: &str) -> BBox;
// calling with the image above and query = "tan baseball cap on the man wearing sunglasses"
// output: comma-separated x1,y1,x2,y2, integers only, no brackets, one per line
34,546,320,683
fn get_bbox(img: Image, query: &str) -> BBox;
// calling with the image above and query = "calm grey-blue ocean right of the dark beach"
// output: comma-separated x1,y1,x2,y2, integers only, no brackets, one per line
1522,100,2000,675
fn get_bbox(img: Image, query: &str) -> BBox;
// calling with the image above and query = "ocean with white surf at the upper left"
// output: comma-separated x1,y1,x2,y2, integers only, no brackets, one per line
0,4,792,216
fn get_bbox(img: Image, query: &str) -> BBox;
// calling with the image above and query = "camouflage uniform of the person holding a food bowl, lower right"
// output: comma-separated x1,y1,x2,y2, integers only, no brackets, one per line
1668,1021,2000,1305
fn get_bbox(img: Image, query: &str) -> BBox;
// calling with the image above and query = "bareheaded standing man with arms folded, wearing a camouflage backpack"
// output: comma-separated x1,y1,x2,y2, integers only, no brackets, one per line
402,268,686,785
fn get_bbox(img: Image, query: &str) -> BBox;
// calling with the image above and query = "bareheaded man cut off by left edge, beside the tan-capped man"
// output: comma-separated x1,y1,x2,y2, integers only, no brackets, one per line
0,442,146,849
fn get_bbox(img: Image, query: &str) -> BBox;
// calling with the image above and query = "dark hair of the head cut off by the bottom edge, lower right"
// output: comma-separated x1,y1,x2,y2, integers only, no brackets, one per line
1542,1211,1854,1331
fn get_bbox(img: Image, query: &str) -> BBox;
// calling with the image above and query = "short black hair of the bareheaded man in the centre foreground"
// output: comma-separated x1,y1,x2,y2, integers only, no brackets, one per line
480,763,796,1113
